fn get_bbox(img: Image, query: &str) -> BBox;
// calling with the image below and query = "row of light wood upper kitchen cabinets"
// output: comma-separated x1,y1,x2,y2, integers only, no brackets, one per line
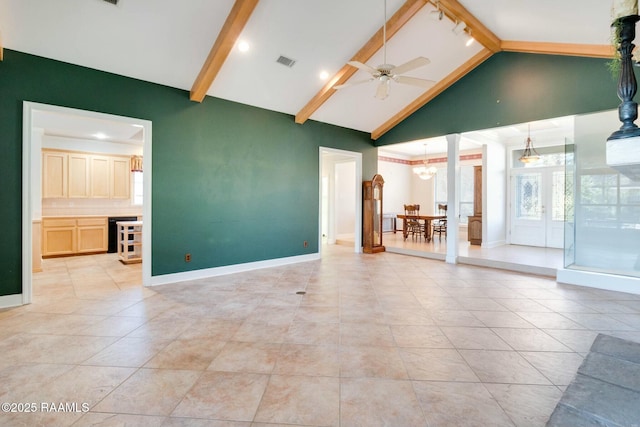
42,150,131,199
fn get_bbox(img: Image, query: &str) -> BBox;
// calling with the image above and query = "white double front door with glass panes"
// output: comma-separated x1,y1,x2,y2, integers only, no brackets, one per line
511,167,565,248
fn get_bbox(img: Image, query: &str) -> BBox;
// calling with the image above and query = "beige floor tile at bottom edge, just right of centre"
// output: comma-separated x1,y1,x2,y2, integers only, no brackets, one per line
340,378,427,427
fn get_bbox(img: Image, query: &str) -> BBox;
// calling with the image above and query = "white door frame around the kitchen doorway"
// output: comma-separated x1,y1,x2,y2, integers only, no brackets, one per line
22,101,153,304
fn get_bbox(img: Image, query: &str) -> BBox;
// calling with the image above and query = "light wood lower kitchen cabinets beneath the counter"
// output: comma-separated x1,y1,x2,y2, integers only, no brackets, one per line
42,217,108,257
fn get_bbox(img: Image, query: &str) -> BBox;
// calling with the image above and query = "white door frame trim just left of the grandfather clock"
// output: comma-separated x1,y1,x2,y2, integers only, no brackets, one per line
318,146,362,255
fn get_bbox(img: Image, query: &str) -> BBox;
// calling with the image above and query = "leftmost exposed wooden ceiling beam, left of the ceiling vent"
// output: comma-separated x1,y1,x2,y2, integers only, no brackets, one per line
189,0,259,102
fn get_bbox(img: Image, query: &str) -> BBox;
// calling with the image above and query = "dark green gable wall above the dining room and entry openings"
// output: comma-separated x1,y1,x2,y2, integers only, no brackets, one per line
375,52,620,146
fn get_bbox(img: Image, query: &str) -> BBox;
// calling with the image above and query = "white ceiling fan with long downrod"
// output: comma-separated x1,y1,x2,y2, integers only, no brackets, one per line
333,0,435,100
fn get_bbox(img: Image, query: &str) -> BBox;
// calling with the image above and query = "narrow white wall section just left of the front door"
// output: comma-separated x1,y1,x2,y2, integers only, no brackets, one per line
482,143,508,248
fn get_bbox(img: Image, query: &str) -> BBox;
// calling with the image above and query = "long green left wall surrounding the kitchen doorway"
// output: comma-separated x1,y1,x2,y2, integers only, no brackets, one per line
0,49,377,296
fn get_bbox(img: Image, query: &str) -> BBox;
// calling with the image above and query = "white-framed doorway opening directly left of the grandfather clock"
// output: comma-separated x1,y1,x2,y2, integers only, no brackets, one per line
318,147,362,255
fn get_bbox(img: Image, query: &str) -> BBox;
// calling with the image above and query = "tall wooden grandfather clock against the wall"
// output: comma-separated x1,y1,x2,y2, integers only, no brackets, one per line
362,174,384,254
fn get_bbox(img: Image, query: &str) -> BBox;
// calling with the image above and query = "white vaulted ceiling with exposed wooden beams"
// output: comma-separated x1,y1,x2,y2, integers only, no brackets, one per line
0,0,613,144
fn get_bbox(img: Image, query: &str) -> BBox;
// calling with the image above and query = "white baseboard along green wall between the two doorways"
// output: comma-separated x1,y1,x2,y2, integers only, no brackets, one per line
150,252,320,286
